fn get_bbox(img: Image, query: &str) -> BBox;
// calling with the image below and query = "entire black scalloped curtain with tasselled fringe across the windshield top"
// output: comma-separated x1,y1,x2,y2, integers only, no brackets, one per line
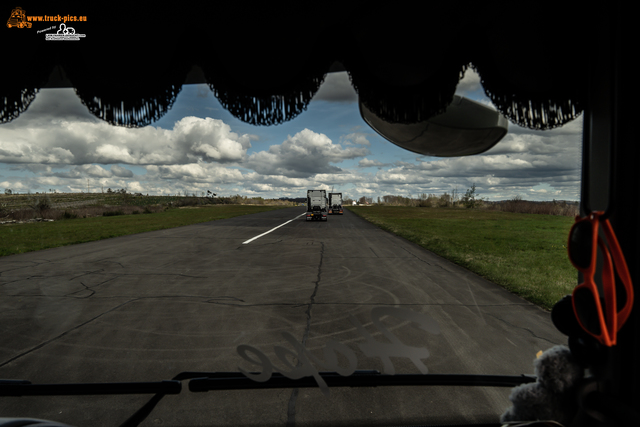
0,1,598,130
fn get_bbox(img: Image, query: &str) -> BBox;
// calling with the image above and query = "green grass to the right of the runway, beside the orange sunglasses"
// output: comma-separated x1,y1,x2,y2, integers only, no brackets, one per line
349,206,577,310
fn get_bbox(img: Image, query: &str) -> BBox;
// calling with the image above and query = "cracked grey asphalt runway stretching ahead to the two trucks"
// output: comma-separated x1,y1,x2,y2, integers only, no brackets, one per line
0,207,566,427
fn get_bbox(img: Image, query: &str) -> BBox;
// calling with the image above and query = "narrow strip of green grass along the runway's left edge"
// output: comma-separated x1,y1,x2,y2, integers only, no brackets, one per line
0,205,284,256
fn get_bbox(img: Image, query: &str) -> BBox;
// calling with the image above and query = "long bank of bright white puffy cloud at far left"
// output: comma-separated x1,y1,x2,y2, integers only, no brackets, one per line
0,96,253,165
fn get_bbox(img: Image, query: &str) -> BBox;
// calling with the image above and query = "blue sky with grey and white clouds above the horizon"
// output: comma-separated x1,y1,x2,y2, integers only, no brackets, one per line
0,70,582,201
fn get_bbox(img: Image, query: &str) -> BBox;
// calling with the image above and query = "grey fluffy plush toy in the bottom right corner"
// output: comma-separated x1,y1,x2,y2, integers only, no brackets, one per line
500,345,584,425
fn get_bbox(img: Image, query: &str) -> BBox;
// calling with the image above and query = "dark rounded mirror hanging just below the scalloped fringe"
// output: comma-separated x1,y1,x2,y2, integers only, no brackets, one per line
359,95,509,157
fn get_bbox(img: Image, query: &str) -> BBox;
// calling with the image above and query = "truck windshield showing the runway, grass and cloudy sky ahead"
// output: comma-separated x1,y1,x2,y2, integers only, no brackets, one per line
0,70,582,427
